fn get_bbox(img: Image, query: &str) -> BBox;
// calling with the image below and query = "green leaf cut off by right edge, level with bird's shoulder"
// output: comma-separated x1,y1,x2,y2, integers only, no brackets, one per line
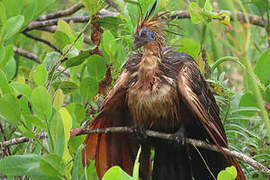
254,49,270,86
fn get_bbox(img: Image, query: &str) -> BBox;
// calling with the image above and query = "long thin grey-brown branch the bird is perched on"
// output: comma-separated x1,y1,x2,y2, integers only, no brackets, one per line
70,127,270,177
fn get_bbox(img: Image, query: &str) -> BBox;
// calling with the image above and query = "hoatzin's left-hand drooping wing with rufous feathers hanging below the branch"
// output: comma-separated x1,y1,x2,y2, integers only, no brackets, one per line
82,54,150,179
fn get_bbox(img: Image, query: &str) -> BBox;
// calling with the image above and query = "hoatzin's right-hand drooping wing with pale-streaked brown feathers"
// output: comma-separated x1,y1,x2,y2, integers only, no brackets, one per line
175,59,245,180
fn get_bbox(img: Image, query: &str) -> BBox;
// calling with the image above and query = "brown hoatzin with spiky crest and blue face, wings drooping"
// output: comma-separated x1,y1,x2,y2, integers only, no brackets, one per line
82,2,245,180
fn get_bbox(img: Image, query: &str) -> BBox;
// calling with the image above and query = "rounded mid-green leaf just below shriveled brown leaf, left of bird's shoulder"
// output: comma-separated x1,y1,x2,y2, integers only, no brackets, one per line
87,55,107,82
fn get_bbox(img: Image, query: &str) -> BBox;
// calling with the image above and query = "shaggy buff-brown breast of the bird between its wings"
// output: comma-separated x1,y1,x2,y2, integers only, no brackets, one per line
127,77,179,132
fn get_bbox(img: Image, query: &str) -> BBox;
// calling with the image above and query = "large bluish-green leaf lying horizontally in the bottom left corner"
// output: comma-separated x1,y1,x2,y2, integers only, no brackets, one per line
0,154,41,176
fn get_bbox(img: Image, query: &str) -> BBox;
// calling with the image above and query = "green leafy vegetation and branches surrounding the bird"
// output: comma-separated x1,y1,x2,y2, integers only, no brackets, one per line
0,0,270,180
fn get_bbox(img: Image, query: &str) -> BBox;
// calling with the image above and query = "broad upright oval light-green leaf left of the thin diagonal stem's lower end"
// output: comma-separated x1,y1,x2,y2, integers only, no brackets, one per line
30,86,52,120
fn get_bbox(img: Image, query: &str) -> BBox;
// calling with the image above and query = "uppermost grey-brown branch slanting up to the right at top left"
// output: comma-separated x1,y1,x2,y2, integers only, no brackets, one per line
36,2,83,21
